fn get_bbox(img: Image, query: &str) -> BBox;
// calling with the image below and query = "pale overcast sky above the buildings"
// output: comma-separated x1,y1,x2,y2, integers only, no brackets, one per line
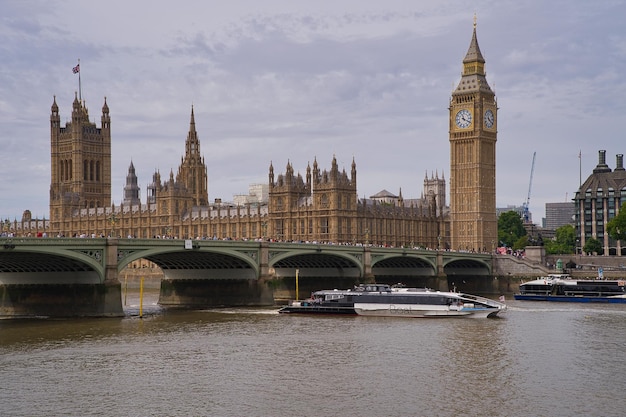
0,0,626,224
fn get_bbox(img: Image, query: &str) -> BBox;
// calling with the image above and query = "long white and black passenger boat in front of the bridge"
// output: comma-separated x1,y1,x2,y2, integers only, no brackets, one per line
278,284,506,318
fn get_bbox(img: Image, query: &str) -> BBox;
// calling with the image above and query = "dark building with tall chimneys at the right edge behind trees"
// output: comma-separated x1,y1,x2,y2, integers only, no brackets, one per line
574,150,626,255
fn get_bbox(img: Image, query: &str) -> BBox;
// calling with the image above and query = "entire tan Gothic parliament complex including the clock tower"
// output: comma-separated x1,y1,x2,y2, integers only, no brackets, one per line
4,23,498,251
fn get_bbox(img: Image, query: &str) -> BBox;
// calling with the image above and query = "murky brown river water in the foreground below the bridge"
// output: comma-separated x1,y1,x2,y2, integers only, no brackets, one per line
0,292,626,417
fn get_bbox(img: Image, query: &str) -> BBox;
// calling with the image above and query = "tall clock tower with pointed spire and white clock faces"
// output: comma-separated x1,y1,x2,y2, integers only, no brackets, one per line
449,17,498,251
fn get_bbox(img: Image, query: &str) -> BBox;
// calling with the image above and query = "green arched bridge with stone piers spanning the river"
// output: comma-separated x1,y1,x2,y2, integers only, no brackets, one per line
0,238,528,317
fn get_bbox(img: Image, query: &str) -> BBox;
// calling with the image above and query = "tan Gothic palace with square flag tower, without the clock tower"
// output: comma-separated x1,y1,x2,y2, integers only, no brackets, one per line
41,100,449,248
